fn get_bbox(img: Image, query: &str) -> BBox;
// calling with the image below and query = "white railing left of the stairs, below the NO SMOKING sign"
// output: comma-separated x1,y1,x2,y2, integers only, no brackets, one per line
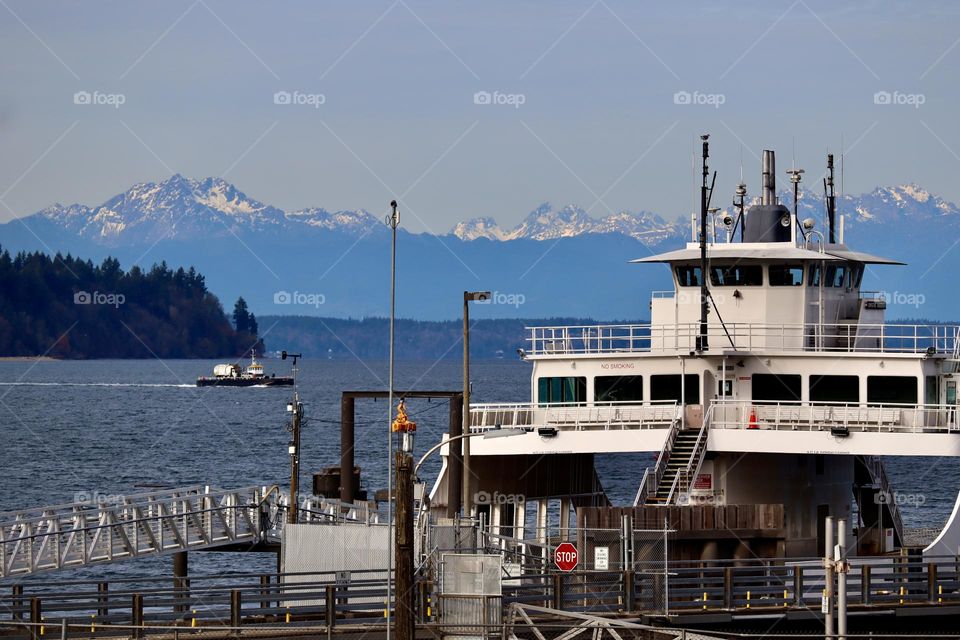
470,401,681,432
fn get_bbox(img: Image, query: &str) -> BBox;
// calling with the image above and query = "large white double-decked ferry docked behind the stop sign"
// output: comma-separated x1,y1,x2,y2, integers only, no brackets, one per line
430,137,960,560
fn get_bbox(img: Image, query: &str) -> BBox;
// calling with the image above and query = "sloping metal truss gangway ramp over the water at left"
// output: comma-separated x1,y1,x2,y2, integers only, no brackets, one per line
0,485,274,578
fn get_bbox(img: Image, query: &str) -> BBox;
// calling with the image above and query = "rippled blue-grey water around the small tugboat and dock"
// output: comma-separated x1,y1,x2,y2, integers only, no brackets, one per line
0,360,960,578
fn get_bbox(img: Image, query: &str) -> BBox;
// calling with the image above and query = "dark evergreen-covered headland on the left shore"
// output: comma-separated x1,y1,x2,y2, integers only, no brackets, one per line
0,250,263,358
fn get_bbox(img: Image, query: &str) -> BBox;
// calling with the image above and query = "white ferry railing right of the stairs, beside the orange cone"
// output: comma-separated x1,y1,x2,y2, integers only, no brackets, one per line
710,400,960,433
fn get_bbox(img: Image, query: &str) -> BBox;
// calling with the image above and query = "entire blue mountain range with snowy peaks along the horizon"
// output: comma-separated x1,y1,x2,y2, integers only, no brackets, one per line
0,174,960,319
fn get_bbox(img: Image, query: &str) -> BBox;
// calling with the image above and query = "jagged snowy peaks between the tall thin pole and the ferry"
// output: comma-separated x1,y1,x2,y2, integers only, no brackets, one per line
451,202,677,244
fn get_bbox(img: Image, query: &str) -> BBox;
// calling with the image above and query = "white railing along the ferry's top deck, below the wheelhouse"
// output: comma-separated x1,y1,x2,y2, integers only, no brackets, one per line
527,322,960,356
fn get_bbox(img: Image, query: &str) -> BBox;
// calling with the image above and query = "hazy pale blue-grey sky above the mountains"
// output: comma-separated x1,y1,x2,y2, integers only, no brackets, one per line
0,0,960,232
